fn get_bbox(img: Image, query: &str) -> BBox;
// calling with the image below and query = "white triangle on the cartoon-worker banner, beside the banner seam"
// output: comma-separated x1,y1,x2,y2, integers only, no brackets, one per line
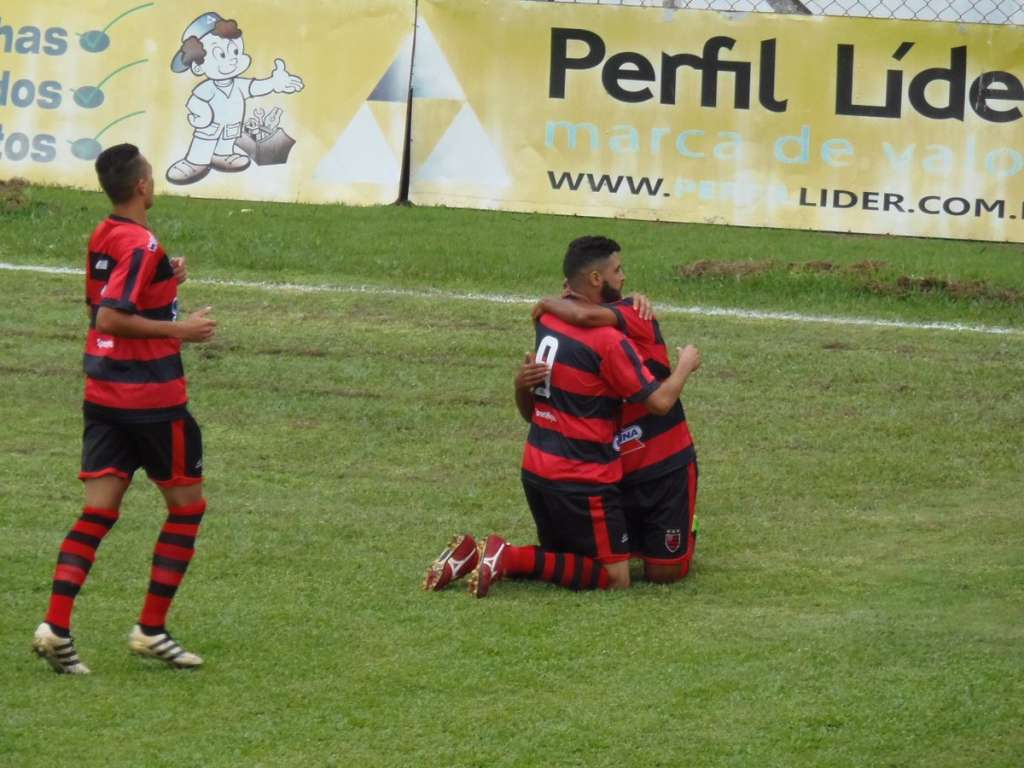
313,103,400,184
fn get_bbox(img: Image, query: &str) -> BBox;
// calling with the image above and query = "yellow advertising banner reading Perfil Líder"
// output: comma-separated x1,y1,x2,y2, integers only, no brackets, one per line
410,0,1024,242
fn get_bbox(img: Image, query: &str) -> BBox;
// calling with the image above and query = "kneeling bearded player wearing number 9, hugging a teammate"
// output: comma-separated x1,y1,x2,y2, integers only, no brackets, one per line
424,237,700,597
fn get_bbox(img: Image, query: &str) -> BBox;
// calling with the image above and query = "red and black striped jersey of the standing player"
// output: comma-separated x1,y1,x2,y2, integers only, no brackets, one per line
84,216,188,422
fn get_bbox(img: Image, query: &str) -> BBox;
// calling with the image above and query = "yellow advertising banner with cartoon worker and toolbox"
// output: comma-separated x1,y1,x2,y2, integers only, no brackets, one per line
0,0,415,204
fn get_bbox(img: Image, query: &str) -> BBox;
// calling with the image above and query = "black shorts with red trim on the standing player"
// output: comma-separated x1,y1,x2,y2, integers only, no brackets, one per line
78,414,203,486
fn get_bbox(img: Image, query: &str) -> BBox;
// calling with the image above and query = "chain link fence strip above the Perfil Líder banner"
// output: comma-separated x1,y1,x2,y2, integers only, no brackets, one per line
554,0,1024,26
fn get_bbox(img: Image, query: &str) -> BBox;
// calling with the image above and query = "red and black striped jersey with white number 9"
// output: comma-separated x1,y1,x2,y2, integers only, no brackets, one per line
522,314,658,489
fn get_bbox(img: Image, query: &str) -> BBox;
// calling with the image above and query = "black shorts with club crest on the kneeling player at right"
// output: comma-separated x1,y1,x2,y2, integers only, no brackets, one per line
621,462,697,564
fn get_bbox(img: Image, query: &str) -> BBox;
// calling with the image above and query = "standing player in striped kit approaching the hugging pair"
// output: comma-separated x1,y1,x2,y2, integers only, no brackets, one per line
32,144,216,675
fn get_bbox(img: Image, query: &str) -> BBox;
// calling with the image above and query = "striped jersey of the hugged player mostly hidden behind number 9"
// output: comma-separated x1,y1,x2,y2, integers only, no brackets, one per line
609,299,696,481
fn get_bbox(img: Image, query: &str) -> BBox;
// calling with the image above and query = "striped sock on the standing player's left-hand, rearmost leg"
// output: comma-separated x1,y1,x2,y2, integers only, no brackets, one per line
46,507,118,637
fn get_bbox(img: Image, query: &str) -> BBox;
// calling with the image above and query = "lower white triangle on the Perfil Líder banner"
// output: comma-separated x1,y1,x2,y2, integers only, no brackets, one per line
415,103,509,186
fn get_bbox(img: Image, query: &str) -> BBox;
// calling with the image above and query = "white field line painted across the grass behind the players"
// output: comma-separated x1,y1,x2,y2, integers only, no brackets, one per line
0,261,1024,336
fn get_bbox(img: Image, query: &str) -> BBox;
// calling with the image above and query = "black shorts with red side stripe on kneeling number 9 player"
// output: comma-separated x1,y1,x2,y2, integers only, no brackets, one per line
522,480,630,563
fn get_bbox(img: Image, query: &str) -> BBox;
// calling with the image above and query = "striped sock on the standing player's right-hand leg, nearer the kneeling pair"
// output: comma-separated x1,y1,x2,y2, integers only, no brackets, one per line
138,499,206,634
